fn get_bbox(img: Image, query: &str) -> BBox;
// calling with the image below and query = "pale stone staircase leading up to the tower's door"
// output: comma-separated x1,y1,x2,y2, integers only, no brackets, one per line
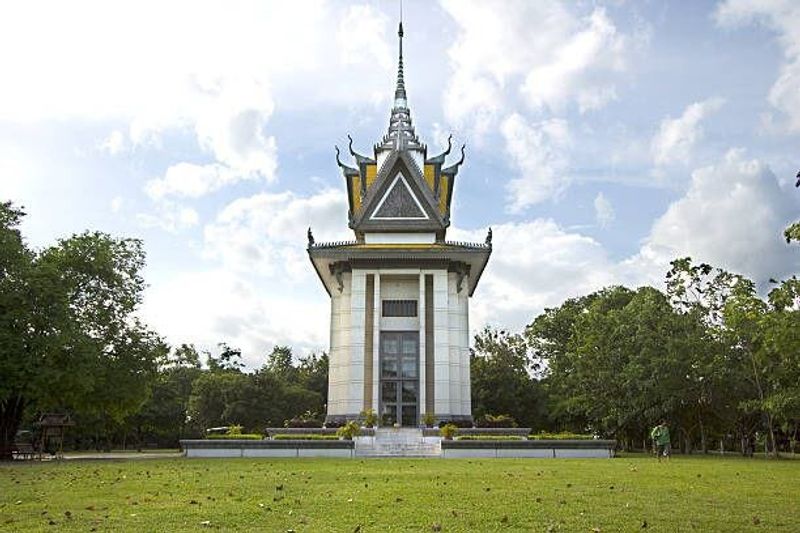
355,427,442,457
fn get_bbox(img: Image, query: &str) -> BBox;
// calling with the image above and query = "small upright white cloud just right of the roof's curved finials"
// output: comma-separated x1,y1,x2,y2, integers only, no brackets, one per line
500,113,571,212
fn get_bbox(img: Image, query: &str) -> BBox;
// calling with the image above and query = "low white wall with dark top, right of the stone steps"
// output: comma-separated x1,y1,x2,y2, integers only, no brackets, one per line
442,439,617,458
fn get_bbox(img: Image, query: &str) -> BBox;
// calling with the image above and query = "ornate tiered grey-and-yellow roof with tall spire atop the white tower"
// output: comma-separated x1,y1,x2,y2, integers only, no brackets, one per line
308,22,492,296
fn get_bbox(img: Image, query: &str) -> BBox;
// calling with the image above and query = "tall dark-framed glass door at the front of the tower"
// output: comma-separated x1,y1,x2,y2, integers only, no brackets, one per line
380,331,419,426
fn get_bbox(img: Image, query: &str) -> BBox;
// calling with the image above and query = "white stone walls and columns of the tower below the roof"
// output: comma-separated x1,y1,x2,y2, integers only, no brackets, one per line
328,268,472,419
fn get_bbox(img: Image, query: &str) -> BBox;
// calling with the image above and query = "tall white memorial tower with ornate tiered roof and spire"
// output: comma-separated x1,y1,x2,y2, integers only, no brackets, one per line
308,22,492,426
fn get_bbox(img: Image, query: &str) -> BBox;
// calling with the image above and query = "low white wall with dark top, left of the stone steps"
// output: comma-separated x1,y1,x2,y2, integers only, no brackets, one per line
180,439,353,458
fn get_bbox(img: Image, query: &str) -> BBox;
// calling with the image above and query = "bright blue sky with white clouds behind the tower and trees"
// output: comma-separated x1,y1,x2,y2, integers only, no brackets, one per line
0,0,800,366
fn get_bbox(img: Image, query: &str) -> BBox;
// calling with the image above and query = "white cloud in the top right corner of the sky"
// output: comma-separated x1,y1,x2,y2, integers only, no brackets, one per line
715,0,800,132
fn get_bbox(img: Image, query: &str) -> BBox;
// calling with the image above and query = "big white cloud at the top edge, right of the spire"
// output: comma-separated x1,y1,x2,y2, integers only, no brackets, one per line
442,0,631,132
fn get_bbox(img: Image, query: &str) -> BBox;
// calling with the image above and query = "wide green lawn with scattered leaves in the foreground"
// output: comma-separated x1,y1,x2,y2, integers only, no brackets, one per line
0,456,800,533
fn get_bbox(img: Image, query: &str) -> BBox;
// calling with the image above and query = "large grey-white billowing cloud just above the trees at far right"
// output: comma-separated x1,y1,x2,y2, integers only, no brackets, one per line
640,150,798,282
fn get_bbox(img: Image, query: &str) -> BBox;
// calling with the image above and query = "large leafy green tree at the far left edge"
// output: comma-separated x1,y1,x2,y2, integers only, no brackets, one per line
0,203,165,458
